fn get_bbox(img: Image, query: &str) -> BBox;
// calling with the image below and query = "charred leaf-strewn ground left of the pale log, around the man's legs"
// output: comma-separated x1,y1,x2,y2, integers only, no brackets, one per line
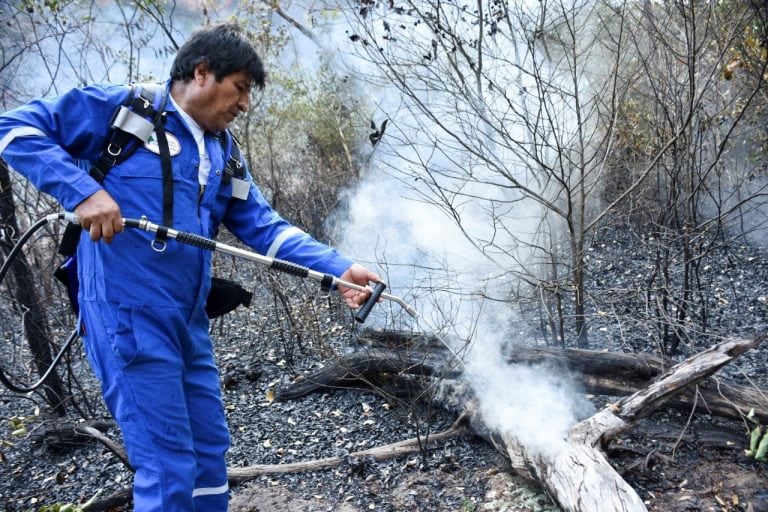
0,275,556,512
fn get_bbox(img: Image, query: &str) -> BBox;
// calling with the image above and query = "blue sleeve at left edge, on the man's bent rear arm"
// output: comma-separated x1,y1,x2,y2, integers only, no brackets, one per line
0,85,129,211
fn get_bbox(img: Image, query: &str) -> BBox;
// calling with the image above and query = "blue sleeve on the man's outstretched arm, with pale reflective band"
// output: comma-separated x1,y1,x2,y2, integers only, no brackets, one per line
224,163,353,277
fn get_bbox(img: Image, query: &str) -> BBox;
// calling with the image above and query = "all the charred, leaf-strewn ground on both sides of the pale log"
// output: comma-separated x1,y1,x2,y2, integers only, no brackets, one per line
0,226,768,512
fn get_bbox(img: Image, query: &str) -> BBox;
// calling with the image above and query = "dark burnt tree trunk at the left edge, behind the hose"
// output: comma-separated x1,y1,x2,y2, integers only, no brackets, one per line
0,159,66,416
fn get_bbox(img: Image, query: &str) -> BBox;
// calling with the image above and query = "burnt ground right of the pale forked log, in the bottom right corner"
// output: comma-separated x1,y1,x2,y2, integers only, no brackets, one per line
609,413,768,512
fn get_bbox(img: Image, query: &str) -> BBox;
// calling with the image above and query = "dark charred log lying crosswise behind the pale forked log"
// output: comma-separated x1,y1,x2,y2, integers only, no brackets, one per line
277,340,768,424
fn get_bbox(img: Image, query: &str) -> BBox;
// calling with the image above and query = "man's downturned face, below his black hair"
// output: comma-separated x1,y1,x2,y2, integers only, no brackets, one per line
192,66,253,132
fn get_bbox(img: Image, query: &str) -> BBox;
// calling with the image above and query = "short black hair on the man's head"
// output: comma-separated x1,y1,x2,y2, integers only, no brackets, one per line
171,22,266,89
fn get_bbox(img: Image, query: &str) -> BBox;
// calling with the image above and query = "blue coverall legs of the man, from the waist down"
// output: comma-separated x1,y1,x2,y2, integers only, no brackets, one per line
81,301,229,512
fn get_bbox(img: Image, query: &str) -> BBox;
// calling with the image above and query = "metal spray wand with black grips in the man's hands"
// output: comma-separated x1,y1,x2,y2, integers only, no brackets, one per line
118,217,419,322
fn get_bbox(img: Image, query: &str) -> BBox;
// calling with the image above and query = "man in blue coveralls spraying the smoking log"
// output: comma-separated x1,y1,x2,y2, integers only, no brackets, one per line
0,24,380,512
